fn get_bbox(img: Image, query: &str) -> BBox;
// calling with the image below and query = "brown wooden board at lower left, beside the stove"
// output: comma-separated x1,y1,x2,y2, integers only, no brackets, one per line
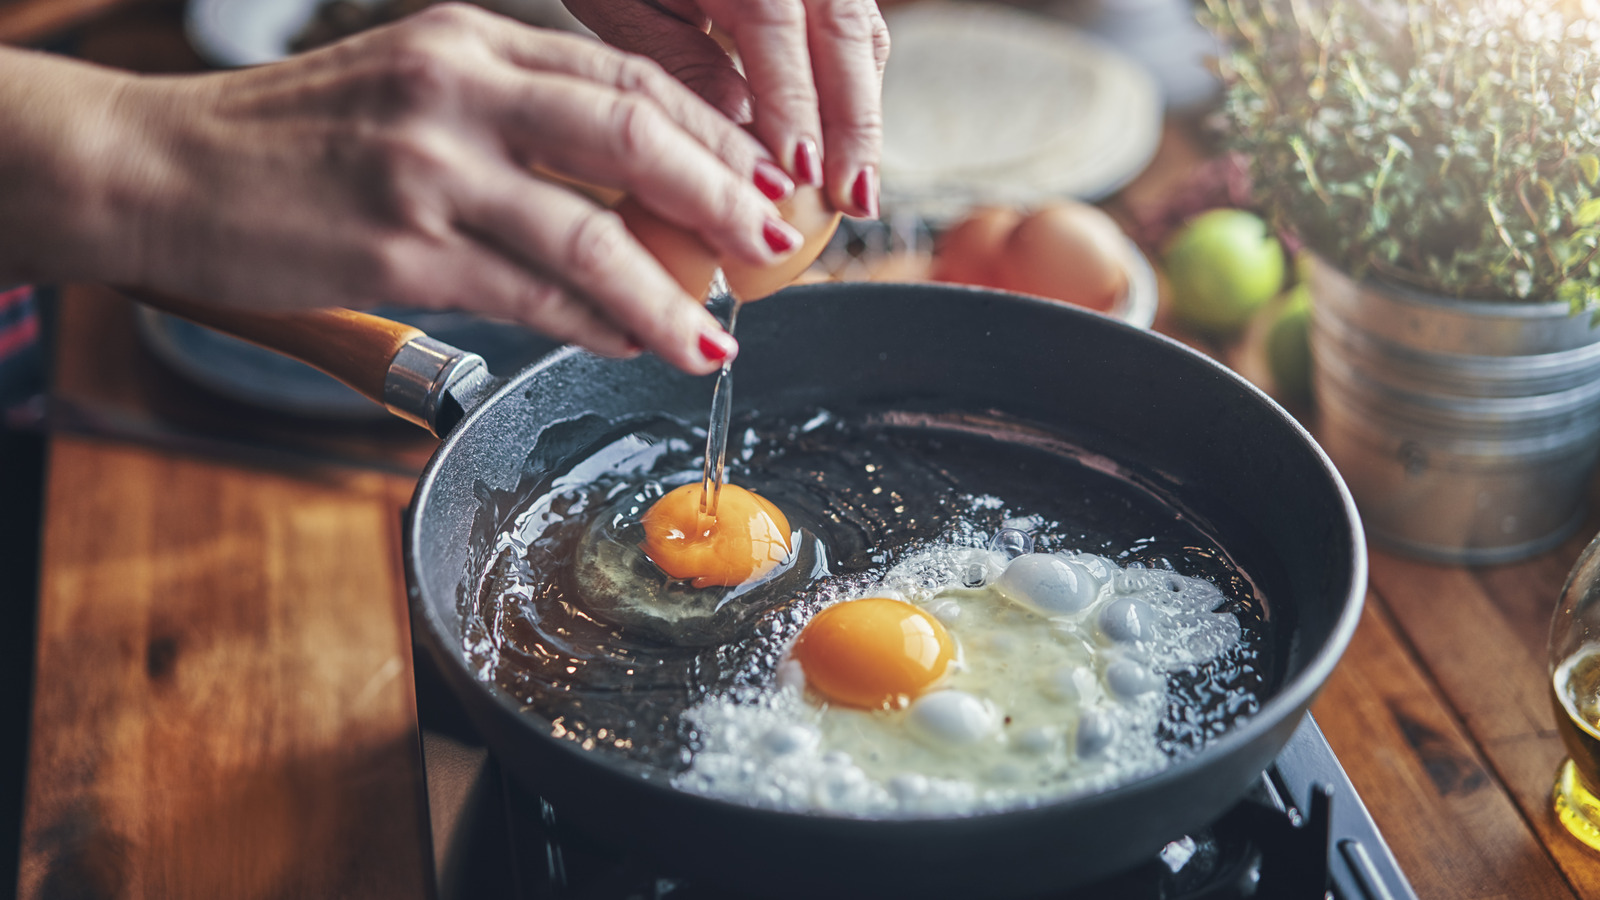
21,437,429,900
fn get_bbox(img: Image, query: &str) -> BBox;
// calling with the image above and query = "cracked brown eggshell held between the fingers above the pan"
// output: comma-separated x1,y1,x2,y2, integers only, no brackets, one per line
616,186,840,303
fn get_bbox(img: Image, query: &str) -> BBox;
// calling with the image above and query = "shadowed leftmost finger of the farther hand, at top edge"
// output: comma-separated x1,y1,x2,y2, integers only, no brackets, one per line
553,3,752,125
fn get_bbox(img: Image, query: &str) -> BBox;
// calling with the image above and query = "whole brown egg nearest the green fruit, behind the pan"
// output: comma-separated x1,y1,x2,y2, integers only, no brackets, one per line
995,202,1128,312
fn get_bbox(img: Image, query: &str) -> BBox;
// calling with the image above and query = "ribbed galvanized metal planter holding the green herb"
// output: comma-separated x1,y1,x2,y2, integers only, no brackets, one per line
1310,259,1600,564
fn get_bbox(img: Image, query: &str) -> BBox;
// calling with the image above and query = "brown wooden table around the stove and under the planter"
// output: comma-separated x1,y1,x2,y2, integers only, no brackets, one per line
9,7,1600,900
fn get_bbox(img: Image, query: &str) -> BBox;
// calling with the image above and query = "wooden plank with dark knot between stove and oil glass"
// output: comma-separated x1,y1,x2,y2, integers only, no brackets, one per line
1314,596,1573,900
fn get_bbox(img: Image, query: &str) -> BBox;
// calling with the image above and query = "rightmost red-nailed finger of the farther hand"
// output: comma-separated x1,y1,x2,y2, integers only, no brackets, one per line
806,0,890,218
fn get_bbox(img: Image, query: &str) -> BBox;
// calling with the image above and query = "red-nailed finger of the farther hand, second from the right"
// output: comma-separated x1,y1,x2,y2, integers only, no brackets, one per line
701,0,822,187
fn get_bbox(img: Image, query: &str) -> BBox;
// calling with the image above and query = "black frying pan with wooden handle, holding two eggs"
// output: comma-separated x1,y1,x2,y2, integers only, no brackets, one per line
134,285,1366,897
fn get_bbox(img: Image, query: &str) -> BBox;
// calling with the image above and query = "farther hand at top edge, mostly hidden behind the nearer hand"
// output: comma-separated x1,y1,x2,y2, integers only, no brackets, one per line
565,0,890,218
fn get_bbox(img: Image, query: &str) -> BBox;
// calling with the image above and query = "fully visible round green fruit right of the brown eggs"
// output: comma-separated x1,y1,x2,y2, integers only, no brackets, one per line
1162,210,1285,338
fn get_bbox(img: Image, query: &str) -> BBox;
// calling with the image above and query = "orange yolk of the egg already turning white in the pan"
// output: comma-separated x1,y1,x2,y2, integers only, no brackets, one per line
790,597,955,709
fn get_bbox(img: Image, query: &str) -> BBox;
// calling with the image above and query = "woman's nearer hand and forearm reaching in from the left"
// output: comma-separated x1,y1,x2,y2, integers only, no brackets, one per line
0,5,812,373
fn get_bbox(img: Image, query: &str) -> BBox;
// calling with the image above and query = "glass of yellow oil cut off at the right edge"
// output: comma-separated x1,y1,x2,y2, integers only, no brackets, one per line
1550,535,1600,850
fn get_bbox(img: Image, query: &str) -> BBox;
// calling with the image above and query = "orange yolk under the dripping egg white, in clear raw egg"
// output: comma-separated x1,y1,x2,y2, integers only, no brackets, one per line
643,482,790,588
